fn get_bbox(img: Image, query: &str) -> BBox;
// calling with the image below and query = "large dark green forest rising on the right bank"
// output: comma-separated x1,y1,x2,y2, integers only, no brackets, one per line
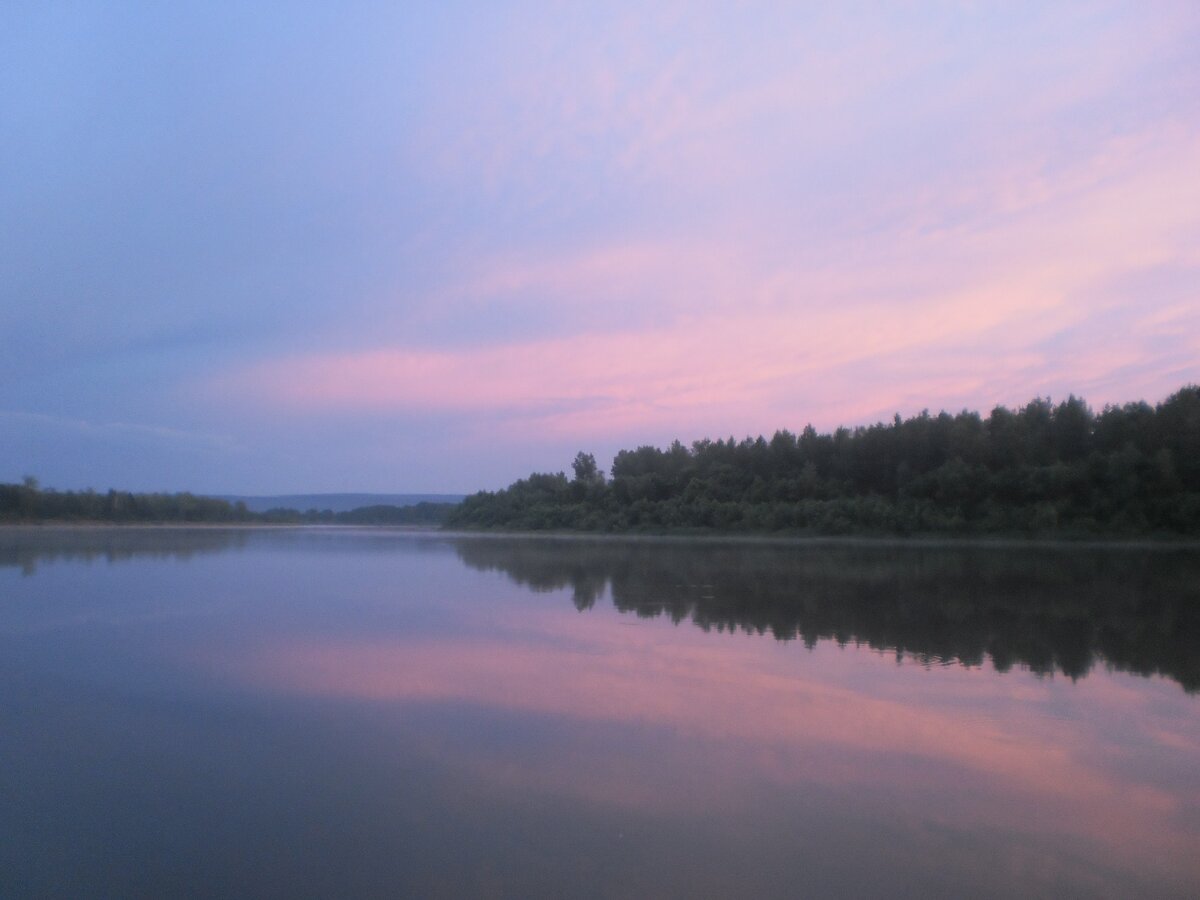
446,385,1200,536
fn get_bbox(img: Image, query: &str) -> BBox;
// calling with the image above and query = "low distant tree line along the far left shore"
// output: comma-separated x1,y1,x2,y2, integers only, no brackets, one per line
0,478,454,526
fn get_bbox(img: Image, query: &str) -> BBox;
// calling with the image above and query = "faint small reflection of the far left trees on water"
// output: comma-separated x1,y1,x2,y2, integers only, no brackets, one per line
0,527,250,575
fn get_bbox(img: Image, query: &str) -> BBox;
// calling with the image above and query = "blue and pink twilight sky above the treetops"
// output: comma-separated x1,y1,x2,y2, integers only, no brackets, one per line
0,0,1200,494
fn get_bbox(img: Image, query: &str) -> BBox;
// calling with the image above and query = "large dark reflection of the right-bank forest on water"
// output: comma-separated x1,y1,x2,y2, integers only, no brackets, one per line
455,539,1200,691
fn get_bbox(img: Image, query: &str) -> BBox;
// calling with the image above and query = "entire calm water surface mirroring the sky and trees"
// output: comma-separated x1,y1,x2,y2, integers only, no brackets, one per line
0,528,1200,898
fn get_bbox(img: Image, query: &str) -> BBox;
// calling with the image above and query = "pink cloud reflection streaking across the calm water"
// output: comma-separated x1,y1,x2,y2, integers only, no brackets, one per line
201,602,1200,877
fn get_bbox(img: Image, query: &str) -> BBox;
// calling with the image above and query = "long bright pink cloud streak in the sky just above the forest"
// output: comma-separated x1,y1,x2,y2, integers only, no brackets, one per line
206,237,1188,436
